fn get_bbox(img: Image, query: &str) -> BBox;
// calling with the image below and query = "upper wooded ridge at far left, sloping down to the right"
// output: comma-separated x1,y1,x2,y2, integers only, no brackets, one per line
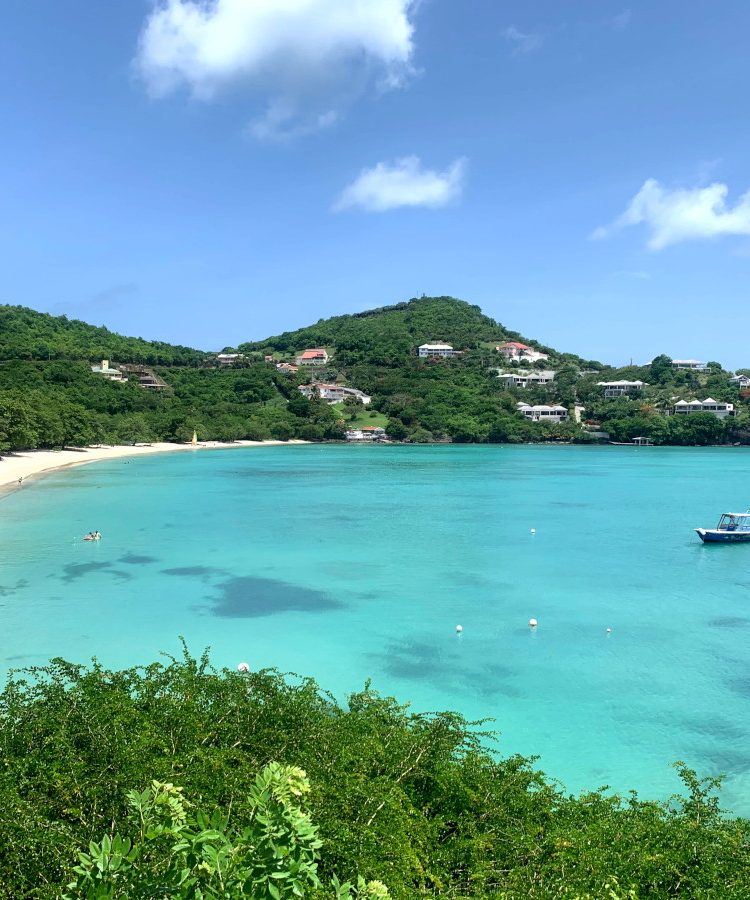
0,306,208,366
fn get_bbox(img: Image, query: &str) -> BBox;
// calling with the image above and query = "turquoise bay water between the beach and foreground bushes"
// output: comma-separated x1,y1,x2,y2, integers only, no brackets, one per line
0,445,750,814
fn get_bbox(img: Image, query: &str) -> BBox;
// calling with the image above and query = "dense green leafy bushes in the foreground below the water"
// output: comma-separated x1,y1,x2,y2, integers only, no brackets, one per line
0,654,750,900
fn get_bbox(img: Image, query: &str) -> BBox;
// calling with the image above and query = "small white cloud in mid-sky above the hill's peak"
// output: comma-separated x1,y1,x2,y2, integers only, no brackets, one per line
334,156,466,212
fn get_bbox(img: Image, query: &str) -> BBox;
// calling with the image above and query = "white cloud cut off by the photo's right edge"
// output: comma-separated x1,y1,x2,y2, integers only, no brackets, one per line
591,178,750,250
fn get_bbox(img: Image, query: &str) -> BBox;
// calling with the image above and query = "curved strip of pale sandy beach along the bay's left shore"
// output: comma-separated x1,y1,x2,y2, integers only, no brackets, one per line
0,441,307,490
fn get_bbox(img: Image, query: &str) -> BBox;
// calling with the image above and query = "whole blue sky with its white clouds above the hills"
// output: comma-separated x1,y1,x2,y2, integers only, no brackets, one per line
0,0,750,367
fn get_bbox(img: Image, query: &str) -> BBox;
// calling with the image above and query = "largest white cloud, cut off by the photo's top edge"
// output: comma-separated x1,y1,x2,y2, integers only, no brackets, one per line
135,0,416,99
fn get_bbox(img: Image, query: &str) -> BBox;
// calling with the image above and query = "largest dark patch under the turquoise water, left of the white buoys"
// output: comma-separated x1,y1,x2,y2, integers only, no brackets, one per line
213,575,343,619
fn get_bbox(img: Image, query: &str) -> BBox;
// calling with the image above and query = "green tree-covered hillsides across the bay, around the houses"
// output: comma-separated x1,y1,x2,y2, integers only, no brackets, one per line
0,297,750,450
